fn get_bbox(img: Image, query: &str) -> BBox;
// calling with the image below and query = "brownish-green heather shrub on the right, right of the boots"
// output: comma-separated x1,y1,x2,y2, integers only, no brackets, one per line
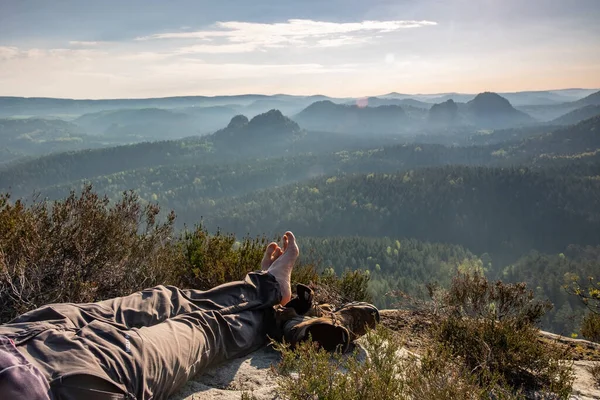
434,273,573,398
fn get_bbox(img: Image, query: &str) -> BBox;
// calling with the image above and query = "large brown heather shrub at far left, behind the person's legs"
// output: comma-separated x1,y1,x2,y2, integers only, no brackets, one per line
0,186,182,322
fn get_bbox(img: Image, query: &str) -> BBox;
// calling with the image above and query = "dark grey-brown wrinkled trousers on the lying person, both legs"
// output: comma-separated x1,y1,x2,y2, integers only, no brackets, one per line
0,272,281,400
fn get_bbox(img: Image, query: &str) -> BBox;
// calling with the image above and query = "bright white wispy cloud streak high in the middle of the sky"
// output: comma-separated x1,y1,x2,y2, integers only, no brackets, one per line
136,19,437,53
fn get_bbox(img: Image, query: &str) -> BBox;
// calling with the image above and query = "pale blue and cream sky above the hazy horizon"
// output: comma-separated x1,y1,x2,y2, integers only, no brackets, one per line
0,0,600,99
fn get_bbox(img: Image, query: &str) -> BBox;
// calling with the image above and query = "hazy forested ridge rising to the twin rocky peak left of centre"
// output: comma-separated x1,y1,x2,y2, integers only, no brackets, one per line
0,110,418,196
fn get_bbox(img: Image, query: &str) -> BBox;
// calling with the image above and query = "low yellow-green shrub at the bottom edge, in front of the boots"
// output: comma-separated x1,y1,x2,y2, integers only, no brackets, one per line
274,326,518,400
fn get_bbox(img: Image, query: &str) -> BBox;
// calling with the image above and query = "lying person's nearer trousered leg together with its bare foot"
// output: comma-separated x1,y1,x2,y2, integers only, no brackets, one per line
17,233,298,399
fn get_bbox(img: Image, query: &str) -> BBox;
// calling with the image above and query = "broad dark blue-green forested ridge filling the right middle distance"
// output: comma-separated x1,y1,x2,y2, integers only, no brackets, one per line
189,164,600,255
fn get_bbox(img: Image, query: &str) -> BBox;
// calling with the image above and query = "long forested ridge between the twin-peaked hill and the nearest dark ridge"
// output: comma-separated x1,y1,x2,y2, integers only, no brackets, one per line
29,144,498,205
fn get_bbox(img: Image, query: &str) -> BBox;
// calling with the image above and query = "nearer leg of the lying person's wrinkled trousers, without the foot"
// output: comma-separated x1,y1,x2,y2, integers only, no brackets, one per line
32,272,281,399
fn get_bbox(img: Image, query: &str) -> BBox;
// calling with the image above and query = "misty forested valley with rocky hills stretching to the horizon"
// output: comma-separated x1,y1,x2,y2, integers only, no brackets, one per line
0,89,600,335
